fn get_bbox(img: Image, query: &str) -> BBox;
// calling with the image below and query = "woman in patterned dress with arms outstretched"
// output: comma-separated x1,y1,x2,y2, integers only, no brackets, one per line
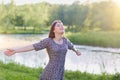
4,20,81,80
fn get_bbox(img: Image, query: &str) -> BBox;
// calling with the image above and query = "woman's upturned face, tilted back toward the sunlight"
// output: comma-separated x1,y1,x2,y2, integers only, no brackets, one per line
54,22,65,34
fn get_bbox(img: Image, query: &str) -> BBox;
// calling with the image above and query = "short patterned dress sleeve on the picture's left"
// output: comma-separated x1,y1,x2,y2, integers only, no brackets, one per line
33,38,49,51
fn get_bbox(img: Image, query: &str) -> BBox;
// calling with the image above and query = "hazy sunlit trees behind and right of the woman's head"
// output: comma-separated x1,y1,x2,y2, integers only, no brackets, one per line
50,1,120,32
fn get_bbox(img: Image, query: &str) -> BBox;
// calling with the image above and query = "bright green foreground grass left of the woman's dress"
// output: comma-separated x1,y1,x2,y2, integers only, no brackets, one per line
0,62,42,80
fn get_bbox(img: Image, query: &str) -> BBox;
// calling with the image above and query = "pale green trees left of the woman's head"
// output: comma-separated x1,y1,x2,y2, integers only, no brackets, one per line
0,1,50,33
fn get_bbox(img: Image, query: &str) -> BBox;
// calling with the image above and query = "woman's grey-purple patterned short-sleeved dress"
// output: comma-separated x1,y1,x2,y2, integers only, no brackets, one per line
33,38,73,80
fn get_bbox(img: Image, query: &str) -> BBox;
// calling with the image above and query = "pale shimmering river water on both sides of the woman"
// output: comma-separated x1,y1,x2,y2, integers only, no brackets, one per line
0,34,120,74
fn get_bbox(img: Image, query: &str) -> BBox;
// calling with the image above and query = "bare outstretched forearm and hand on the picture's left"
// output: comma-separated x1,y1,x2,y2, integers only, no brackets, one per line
4,45,34,56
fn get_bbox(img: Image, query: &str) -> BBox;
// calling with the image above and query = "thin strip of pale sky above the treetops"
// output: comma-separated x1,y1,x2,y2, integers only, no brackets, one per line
0,0,120,5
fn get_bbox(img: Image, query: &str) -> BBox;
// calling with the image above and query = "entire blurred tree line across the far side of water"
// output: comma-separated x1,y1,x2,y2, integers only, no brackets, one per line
0,0,120,31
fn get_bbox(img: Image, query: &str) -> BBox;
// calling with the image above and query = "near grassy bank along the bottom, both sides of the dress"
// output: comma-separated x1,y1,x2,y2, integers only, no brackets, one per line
0,62,120,80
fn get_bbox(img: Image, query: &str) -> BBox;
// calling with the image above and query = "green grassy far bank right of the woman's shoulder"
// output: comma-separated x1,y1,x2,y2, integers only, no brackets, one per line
66,31,120,48
